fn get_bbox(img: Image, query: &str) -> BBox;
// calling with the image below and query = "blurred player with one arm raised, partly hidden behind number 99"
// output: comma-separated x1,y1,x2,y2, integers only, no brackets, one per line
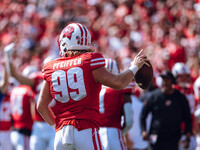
4,44,55,150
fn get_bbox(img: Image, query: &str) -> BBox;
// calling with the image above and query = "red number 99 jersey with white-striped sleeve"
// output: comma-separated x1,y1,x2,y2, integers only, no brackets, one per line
43,53,105,129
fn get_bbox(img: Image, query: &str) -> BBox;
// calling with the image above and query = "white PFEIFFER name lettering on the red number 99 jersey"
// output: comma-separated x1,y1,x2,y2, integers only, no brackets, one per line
53,58,81,69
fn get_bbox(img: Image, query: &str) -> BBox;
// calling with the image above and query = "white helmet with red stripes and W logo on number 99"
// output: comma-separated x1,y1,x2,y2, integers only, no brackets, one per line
58,23,93,57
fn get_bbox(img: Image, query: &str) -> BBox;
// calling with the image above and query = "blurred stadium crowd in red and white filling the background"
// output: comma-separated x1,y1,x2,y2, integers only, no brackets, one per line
0,0,200,149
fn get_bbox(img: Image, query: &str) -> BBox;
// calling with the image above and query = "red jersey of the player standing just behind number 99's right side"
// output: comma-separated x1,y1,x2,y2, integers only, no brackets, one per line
99,86,132,129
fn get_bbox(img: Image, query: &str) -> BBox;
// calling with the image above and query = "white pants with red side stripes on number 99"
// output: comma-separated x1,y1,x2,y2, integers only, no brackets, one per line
54,125,102,150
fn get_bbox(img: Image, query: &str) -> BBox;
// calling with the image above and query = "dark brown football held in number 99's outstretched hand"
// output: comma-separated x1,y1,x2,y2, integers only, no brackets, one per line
135,61,153,90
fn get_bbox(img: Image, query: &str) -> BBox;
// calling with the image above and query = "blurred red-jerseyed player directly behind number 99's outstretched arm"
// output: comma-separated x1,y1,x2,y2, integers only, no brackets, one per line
99,58,133,150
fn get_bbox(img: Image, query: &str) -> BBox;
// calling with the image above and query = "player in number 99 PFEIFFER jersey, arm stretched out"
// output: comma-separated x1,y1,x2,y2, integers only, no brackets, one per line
37,23,148,150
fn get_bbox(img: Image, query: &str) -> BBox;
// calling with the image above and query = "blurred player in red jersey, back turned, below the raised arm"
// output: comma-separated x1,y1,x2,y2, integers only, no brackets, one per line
10,82,35,150
